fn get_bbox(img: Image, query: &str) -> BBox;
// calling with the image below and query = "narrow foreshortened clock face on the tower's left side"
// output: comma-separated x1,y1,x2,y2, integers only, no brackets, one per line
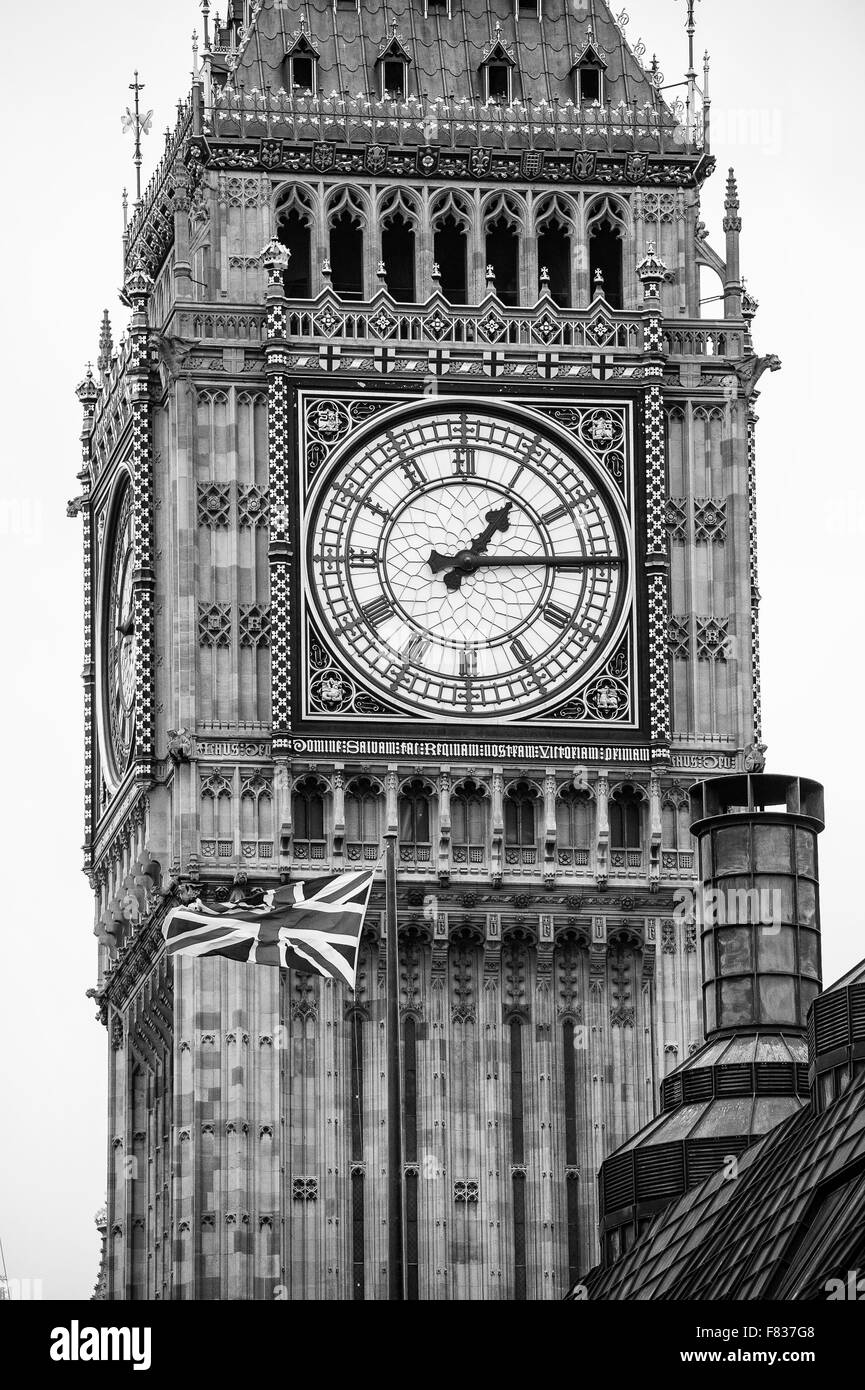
103,485,135,777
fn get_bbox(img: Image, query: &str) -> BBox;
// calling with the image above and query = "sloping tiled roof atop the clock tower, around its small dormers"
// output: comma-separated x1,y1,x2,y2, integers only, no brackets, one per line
236,0,667,106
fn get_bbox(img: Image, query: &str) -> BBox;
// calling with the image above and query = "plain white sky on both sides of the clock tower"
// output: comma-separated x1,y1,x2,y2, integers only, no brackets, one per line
0,0,865,1298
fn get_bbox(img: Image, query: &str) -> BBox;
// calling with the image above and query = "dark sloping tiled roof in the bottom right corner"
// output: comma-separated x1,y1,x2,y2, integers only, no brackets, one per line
575,1079,865,1300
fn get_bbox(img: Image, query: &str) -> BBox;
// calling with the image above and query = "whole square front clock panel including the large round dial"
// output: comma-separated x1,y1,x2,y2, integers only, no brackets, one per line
295,392,640,737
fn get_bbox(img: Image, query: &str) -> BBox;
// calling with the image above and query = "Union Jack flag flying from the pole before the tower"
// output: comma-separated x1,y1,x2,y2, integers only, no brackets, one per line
163,869,375,990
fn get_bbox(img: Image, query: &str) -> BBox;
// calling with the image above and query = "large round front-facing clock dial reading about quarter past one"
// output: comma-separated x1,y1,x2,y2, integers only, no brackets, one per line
306,407,629,720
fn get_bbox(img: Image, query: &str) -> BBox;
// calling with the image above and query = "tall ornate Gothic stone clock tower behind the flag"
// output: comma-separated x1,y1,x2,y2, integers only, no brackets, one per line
72,0,777,1300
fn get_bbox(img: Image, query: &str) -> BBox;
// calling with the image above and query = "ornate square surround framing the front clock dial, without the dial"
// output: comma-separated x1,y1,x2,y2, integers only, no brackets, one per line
291,386,648,746
